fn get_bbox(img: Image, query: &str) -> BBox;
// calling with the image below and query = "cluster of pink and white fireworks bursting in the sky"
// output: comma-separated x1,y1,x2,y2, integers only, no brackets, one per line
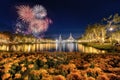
16,5,51,37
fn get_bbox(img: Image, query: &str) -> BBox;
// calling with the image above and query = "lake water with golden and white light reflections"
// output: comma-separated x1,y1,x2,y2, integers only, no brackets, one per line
0,42,105,53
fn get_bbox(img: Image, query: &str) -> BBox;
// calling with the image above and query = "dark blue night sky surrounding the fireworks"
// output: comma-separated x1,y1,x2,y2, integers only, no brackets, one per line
0,0,120,37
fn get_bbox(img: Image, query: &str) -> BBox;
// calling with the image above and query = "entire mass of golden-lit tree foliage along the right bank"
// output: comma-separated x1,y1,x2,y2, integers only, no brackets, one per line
82,14,120,43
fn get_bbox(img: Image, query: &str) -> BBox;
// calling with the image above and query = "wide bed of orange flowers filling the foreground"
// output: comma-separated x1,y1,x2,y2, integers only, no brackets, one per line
0,52,120,80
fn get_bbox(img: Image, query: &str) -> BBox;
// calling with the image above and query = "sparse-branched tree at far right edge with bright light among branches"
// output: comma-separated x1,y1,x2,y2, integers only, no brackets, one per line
103,14,120,42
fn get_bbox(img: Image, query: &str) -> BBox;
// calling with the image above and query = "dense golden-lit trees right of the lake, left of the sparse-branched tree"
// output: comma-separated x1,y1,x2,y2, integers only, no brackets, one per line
83,23,106,43
